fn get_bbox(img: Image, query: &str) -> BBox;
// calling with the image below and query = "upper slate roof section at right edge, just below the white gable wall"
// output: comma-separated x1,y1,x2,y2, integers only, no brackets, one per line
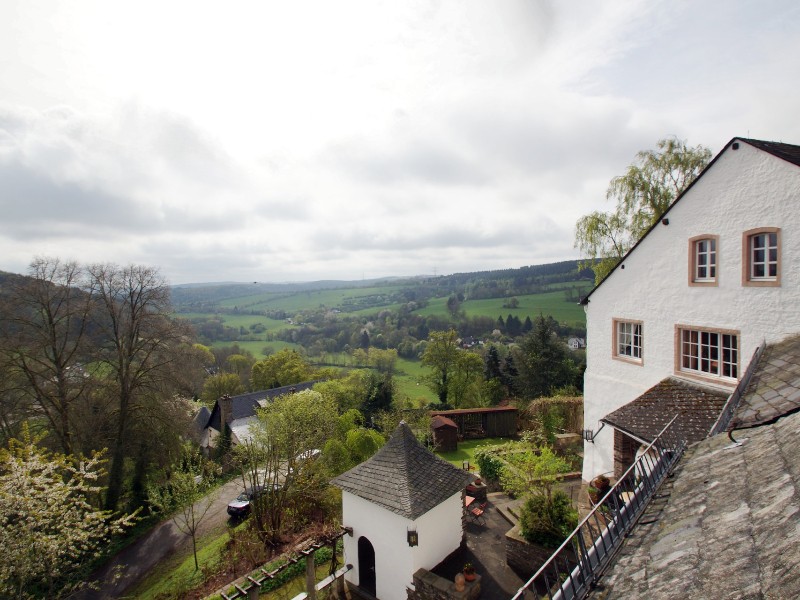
728,335,800,430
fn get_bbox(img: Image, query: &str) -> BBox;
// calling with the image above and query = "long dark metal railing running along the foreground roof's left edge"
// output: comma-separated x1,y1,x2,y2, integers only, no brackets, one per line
513,415,686,600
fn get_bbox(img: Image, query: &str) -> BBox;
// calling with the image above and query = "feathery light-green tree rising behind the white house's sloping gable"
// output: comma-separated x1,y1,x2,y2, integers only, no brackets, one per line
575,138,711,283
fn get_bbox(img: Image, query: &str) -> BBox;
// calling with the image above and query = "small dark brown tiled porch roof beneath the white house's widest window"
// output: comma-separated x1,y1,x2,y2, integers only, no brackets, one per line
601,377,728,443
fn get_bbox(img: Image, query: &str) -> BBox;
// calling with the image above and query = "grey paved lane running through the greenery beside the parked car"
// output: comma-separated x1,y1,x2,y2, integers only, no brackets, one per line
72,478,242,600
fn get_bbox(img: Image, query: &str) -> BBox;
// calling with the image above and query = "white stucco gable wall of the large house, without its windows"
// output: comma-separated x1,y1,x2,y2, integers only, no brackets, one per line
583,142,800,480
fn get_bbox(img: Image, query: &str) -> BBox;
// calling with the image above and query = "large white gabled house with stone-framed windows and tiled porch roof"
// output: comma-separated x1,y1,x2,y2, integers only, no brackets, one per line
583,138,800,480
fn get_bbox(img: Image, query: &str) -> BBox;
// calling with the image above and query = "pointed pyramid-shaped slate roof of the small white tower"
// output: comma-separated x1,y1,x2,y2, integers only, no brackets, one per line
332,423,475,520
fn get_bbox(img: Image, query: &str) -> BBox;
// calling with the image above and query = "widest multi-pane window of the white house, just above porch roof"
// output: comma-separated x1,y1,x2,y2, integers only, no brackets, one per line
678,327,739,379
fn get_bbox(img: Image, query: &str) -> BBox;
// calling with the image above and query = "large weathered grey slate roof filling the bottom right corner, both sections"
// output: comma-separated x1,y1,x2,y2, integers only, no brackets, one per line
592,336,800,600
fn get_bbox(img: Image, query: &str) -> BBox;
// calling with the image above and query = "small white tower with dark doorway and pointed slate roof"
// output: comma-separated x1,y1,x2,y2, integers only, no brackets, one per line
333,423,474,600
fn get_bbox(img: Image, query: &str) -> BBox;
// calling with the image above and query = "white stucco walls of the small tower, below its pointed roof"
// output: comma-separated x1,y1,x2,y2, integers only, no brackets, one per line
342,491,462,600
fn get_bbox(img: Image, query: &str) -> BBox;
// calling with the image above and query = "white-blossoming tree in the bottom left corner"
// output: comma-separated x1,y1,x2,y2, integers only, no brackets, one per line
0,428,135,598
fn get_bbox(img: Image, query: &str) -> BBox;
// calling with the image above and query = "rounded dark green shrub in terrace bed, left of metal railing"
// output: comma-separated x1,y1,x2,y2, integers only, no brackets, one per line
520,490,578,548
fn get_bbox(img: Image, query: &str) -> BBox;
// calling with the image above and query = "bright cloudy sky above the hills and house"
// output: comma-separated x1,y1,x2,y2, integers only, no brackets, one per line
0,0,800,284
